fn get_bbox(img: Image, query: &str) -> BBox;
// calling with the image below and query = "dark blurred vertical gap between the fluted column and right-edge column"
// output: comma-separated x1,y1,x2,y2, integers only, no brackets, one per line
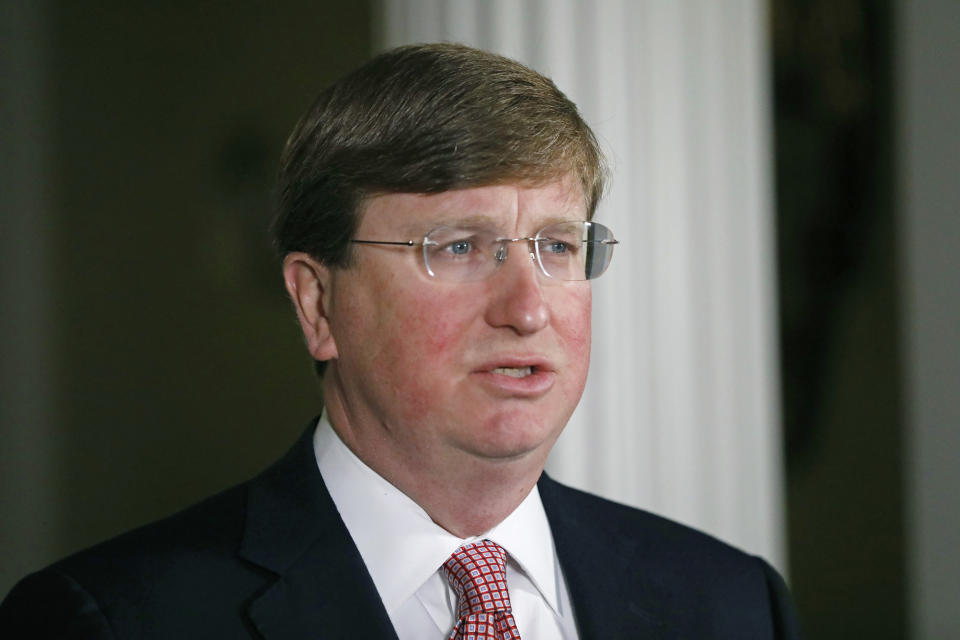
772,0,907,638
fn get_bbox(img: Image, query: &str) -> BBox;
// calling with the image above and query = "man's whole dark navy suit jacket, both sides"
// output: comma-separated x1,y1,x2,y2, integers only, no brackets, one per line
0,422,797,640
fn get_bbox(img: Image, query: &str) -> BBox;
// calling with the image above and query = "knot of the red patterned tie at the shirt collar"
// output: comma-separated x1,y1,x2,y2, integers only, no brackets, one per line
443,540,510,617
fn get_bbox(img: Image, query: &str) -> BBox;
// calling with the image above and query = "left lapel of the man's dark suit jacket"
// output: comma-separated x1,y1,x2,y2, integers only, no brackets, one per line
240,421,396,640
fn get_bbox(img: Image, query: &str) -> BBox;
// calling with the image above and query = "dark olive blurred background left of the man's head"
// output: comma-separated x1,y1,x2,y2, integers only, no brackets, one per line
0,0,372,593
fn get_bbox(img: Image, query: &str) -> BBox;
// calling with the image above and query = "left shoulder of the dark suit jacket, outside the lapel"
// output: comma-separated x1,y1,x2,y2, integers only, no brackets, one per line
0,485,263,638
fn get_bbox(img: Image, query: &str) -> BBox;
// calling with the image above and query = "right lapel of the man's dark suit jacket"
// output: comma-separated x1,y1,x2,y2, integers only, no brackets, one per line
538,474,672,640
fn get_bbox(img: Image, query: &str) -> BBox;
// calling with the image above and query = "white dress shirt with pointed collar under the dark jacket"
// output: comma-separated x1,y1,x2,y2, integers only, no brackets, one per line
313,413,577,640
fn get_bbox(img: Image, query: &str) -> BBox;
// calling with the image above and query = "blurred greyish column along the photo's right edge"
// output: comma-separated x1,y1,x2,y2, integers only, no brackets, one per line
894,0,960,640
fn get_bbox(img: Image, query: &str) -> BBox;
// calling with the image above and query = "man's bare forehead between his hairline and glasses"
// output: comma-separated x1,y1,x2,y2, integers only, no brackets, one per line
358,175,586,235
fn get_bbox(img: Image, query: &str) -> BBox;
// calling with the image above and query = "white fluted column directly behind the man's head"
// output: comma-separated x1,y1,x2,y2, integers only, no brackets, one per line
380,0,784,567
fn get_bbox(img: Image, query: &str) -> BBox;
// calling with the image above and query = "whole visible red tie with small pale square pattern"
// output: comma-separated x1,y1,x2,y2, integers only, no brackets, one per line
443,540,520,640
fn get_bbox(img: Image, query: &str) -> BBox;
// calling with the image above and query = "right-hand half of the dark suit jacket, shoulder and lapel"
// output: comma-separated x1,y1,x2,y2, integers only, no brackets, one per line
538,476,799,638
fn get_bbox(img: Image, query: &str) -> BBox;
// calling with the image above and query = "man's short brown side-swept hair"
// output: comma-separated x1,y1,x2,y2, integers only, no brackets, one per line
273,44,605,267
